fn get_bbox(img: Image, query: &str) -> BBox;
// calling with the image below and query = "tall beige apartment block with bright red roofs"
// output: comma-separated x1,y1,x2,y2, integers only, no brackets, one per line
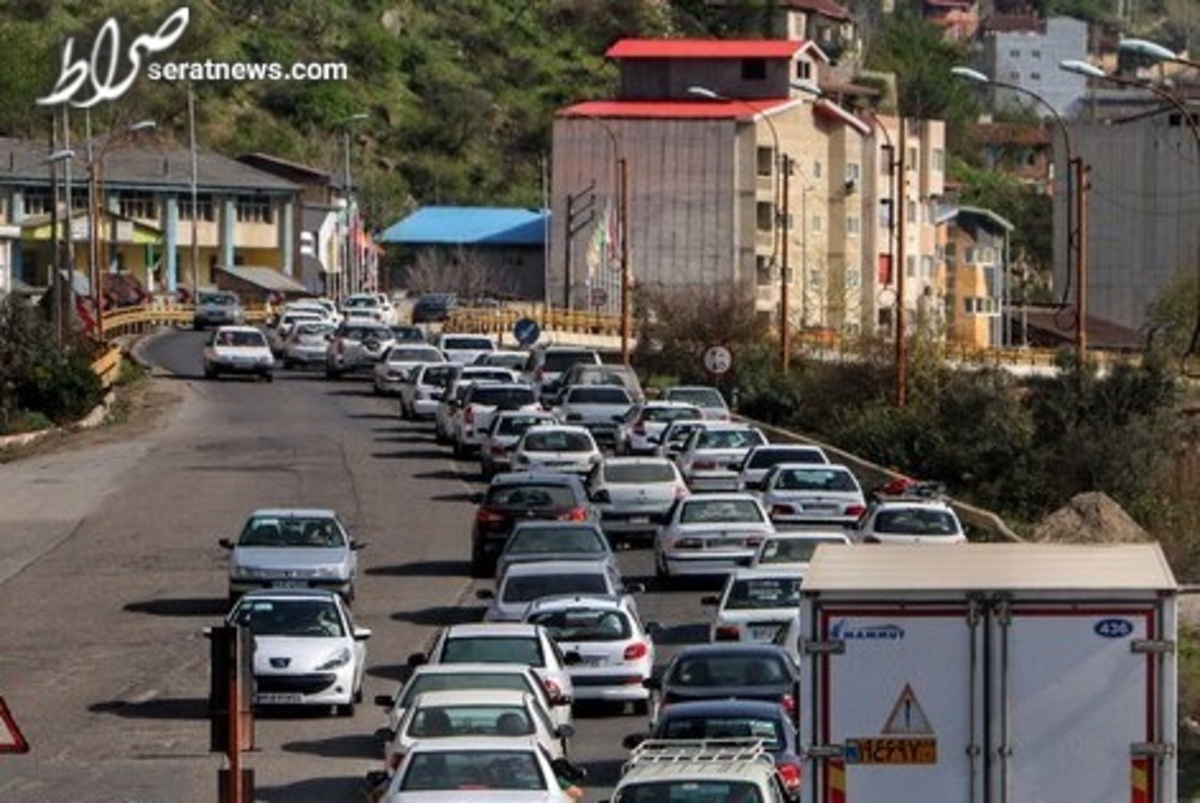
547,40,944,332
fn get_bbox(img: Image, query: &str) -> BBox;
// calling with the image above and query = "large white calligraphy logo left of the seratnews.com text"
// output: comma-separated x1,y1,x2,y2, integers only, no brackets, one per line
37,7,191,109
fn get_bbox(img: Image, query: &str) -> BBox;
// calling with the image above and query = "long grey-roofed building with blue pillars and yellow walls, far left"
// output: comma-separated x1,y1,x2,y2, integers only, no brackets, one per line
0,138,299,302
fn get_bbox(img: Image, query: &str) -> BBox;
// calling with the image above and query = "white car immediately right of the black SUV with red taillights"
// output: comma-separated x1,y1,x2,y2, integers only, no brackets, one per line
587,457,689,541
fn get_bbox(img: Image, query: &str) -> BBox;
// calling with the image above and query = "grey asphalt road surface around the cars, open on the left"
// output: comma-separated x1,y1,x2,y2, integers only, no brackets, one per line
0,331,707,803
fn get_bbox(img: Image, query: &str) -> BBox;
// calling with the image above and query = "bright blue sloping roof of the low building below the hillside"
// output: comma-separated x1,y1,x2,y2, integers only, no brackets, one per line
377,206,550,245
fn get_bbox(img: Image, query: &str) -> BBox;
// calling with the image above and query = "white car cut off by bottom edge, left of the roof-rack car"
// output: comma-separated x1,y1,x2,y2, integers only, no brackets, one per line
368,736,575,803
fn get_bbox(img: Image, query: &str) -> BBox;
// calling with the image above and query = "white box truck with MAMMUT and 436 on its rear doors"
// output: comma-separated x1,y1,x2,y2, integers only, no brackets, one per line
799,544,1178,803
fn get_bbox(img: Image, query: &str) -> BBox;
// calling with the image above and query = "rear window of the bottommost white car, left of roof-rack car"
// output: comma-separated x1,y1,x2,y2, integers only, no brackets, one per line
400,750,546,792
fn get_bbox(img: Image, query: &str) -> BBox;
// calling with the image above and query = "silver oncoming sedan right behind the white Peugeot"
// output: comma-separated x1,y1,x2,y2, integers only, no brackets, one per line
218,508,366,600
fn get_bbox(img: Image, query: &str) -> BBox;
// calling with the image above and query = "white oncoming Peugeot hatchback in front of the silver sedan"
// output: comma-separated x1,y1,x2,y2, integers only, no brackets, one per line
227,588,371,715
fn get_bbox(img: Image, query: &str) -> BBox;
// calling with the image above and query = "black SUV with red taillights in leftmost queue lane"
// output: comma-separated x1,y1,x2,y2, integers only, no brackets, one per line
470,472,599,577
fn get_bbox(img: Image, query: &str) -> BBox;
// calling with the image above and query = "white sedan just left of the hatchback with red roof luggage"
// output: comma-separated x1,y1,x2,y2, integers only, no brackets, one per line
760,463,866,528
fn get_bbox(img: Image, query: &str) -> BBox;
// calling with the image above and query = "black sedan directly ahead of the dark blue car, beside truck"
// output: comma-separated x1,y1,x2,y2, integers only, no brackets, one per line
646,642,800,723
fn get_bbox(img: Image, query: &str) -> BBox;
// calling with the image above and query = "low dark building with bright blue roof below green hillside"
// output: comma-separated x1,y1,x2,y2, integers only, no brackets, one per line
378,206,548,301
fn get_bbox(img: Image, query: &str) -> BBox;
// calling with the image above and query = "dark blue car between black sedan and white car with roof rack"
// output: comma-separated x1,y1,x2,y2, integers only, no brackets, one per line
623,700,803,798
